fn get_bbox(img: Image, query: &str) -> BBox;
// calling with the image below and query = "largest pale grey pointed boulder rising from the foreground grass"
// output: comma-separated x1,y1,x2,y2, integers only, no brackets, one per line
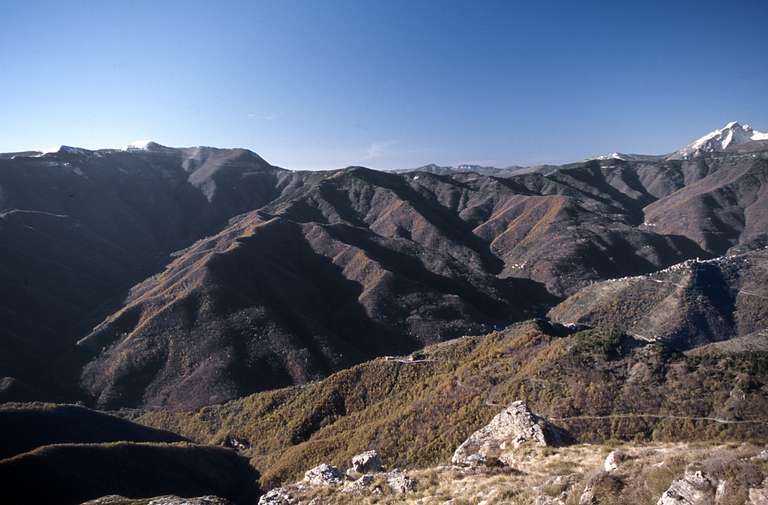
451,401,569,467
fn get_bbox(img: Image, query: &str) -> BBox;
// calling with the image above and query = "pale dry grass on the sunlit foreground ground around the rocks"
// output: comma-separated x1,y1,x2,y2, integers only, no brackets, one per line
260,443,768,505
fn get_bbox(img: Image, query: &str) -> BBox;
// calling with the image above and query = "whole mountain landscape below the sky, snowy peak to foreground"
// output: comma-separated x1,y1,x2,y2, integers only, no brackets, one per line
0,122,768,505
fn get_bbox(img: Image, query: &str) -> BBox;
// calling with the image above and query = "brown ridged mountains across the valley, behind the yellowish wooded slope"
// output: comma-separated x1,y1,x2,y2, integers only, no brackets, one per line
0,126,768,408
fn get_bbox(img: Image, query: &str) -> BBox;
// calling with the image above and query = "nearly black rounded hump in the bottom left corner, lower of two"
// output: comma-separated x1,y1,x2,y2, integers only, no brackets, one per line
0,442,258,505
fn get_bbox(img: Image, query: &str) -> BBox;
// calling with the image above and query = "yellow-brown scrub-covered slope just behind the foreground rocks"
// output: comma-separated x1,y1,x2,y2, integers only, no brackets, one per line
136,322,768,489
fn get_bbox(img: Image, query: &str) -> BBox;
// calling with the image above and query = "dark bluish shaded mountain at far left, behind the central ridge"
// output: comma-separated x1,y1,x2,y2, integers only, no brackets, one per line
0,147,295,398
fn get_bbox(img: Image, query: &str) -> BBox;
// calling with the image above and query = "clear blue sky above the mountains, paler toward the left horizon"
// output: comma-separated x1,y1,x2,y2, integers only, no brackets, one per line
0,0,768,169
